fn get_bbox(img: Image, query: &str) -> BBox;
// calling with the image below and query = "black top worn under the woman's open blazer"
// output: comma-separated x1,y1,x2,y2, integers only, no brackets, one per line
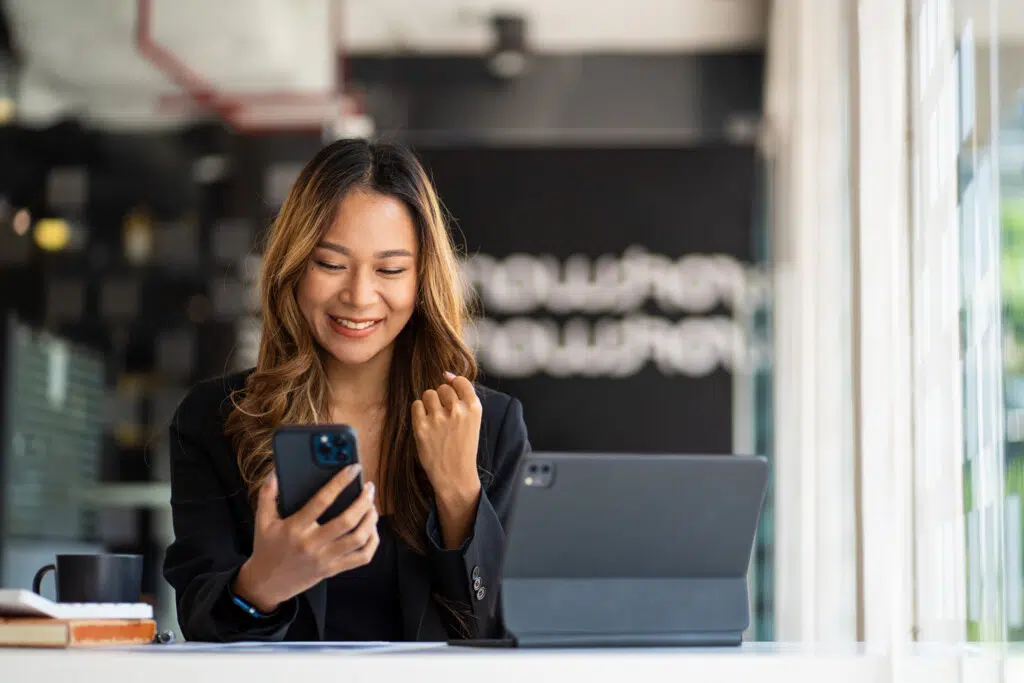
324,517,404,641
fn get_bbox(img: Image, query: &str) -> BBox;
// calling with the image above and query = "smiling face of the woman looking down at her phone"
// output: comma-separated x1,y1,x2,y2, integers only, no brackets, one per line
297,188,418,374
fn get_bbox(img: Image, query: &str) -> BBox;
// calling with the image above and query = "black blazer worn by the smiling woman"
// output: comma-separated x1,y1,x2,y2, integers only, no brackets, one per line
164,373,529,641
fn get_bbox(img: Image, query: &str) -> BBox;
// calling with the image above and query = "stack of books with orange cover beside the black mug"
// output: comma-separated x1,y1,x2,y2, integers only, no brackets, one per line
0,589,157,647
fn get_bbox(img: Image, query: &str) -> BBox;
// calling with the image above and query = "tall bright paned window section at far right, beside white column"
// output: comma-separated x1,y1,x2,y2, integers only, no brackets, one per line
909,0,1003,641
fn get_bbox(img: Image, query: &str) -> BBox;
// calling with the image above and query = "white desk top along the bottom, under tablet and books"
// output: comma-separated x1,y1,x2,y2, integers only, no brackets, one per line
0,643,1024,683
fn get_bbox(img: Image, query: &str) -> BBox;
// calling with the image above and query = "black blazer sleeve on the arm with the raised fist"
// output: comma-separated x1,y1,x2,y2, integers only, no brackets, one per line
427,398,530,638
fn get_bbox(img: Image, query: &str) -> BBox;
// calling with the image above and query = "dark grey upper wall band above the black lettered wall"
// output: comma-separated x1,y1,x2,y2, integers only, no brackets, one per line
349,52,764,142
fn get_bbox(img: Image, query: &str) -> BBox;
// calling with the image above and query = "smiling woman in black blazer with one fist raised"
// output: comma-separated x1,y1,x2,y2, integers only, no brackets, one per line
164,140,529,641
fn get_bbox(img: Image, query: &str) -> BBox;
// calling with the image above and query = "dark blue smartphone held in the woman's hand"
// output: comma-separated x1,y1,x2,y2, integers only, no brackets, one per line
273,425,362,524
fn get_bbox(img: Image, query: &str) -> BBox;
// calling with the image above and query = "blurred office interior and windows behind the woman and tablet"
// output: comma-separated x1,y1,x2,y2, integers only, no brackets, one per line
0,0,1024,642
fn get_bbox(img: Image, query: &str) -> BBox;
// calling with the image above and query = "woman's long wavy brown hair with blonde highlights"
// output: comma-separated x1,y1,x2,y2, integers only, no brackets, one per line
226,140,477,552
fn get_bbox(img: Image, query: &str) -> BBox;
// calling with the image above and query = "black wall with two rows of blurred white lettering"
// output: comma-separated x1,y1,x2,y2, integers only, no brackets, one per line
419,144,755,454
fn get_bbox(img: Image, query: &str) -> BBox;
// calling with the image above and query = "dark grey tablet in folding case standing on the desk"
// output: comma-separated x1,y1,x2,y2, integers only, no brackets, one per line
501,453,768,646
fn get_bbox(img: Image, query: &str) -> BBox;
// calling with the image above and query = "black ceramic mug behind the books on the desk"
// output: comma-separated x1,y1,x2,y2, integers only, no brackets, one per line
32,554,142,602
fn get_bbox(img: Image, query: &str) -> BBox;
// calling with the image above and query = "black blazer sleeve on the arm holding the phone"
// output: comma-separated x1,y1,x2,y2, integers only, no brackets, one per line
164,398,298,642
